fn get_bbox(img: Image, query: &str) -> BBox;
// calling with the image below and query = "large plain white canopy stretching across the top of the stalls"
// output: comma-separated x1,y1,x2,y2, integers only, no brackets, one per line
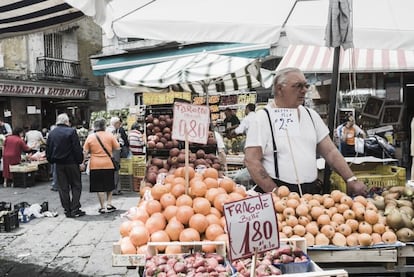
66,0,414,49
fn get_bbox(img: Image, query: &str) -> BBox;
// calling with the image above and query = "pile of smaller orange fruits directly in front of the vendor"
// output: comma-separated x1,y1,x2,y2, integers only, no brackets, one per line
273,186,397,246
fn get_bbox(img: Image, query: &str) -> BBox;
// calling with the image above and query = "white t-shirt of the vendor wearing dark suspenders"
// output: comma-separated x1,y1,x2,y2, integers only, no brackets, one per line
245,105,329,184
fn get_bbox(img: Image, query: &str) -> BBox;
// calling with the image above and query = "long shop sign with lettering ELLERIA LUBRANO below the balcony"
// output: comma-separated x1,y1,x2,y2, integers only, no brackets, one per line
0,82,88,98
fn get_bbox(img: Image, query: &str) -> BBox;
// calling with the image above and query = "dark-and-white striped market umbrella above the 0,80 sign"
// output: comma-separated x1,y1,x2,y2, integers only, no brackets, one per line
106,53,272,94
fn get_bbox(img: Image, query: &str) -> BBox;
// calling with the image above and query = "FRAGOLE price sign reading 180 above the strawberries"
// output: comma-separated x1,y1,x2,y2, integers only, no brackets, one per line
223,193,279,261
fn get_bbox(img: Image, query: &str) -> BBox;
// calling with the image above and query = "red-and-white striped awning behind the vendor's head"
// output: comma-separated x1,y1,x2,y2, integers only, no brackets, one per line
276,45,414,73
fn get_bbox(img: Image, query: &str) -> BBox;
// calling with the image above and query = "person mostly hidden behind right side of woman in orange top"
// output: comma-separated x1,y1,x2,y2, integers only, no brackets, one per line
106,116,129,195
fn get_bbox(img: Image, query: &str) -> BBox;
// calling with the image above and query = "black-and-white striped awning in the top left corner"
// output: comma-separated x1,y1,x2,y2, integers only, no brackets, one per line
0,0,84,38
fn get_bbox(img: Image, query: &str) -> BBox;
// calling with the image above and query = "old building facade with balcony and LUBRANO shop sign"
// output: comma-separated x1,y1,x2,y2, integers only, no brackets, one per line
0,18,106,128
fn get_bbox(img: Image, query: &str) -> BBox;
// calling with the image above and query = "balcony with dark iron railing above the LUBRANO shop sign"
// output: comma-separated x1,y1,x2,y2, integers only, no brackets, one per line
36,57,81,82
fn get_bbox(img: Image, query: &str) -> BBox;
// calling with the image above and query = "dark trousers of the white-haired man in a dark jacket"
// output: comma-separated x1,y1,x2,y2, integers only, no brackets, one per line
56,164,82,214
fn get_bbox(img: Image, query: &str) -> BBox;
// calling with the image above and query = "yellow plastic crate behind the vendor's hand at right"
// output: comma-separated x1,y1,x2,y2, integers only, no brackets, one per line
331,165,406,192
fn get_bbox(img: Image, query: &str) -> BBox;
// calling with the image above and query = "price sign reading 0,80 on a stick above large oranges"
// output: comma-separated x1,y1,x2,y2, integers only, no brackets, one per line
172,102,210,144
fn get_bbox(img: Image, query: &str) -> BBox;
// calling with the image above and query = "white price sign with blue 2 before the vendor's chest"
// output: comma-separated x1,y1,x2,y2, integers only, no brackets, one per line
273,108,300,136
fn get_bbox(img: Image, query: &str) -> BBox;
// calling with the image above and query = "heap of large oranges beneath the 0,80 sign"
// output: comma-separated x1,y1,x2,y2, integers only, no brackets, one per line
120,167,246,254
